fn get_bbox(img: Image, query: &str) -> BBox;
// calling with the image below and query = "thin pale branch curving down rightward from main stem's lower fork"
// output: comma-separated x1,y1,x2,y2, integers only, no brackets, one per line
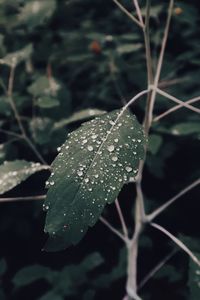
150,223,200,267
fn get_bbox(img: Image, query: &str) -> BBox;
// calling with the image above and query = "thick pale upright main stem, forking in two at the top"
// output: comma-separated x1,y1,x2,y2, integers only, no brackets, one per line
126,0,174,300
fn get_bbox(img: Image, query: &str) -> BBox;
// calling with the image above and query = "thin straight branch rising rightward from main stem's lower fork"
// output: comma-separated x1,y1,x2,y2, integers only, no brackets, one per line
146,178,200,222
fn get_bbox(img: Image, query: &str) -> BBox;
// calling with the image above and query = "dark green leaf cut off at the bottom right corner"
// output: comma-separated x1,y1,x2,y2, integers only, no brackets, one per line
188,253,200,300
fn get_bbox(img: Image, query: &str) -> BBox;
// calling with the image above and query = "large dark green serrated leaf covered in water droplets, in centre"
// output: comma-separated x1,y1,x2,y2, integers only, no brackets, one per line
44,110,145,251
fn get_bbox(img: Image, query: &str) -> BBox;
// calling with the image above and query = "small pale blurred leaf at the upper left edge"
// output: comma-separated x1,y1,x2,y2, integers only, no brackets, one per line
0,44,33,67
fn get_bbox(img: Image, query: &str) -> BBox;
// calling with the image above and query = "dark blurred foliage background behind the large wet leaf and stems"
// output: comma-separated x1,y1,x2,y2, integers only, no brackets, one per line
0,0,200,300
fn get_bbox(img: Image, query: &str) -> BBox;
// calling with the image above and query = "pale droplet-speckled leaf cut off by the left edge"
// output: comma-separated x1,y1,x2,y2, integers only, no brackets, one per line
0,160,49,195
